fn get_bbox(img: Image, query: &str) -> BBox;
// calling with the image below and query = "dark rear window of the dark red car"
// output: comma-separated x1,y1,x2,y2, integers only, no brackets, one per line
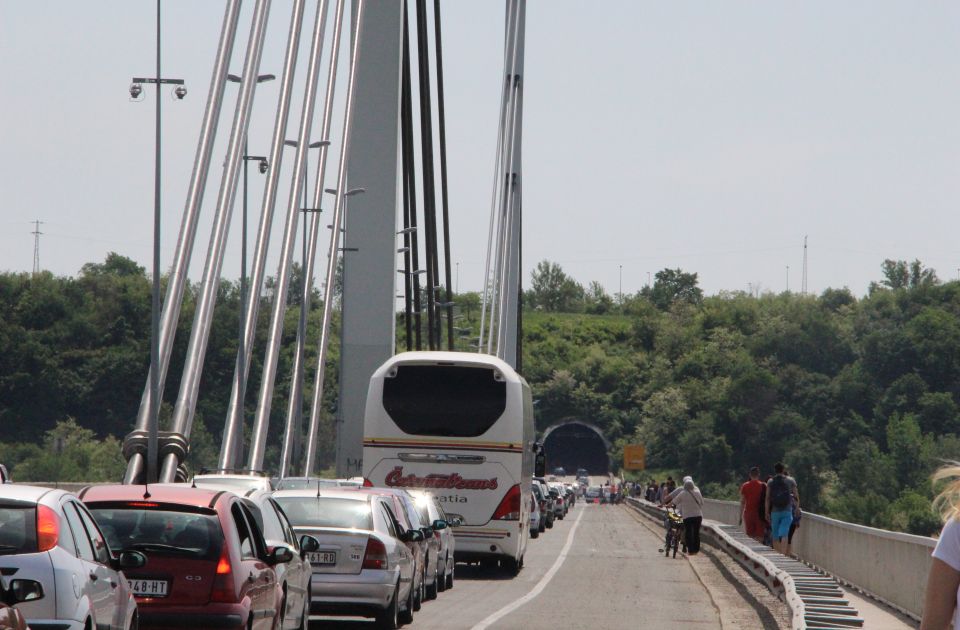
87,502,223,560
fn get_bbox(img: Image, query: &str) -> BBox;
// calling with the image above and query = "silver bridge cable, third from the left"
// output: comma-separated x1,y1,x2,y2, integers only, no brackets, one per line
219,0,306,469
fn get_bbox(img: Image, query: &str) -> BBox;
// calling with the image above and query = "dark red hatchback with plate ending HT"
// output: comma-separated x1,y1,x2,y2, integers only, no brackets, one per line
80,485,293,630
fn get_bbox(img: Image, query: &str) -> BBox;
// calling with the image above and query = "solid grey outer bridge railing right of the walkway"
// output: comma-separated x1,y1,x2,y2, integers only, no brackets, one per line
703,499,936,619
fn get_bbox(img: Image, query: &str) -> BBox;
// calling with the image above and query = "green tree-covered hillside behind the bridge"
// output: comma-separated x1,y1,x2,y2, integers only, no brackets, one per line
0,255,960,534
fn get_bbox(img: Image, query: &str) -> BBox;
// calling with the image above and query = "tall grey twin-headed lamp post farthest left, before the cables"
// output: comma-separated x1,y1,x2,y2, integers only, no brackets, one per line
130,0,187,483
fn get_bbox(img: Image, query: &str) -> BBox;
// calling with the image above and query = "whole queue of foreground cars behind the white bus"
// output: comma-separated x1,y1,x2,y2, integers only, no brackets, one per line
0,474,476,630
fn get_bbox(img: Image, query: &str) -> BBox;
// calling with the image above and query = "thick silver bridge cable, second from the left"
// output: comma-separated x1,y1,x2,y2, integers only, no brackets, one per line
160,0,271,483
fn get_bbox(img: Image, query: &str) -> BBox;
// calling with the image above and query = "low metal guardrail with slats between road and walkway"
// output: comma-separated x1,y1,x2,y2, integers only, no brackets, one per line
627,498,864,630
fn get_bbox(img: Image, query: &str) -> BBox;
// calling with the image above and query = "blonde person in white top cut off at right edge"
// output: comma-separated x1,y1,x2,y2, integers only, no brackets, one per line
920,463,960,630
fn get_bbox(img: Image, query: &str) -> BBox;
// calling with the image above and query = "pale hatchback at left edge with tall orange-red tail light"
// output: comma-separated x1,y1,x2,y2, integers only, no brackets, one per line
0,484,147,630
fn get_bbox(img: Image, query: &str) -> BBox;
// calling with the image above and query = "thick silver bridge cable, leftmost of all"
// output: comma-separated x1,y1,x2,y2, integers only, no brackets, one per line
123,0,240,483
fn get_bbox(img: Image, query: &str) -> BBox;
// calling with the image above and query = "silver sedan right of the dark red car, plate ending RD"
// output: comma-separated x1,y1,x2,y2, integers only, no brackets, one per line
273,489,423,628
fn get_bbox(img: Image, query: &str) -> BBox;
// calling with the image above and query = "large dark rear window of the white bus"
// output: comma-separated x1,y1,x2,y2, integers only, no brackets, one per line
383,365,507,437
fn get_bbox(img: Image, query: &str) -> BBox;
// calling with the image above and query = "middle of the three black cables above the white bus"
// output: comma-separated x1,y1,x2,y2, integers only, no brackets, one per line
417,0,439,350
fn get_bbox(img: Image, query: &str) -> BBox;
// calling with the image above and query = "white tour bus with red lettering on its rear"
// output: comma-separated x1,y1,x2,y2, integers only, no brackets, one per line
363,352,535,573
